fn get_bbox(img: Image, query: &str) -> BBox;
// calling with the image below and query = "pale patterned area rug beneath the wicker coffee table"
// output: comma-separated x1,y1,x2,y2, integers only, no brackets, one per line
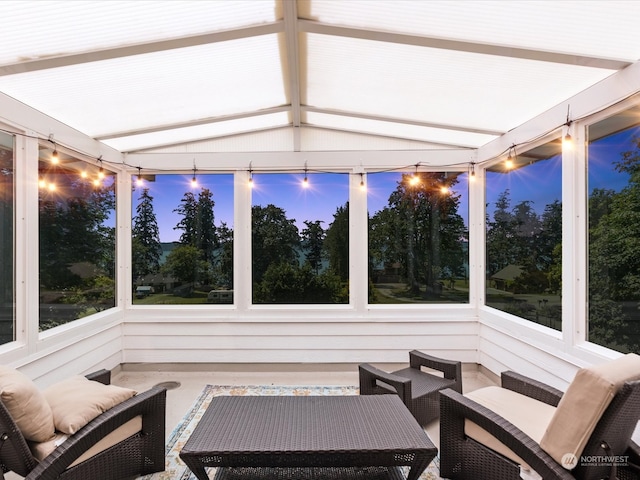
138,385,440,480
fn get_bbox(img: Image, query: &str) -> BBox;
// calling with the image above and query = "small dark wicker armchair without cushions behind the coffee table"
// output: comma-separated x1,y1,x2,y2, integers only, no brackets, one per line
358,350,462,425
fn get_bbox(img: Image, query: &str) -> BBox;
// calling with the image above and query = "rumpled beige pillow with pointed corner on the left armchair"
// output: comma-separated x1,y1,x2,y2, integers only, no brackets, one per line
43,375,137,435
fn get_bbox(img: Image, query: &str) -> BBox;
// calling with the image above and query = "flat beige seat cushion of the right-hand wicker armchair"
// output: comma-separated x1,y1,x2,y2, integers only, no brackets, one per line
464,387,556,470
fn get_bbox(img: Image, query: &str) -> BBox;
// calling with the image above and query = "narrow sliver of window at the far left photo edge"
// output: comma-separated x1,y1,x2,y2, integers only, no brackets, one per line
0,132,15,344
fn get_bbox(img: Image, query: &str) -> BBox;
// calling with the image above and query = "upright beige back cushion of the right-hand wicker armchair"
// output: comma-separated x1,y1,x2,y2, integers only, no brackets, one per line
540,353,640,469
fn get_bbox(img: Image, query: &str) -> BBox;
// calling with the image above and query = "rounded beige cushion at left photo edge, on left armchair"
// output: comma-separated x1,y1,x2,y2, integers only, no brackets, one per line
0,365,55,442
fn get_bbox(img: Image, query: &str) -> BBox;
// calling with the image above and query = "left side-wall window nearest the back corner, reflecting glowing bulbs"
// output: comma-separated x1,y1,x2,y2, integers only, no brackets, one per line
38,145,116,330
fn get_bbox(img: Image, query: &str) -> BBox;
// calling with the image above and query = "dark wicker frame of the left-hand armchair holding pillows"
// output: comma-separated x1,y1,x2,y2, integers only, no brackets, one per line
0,370,166,480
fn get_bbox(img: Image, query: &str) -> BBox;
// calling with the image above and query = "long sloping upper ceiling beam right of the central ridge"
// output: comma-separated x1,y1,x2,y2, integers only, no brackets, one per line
298,20,631,70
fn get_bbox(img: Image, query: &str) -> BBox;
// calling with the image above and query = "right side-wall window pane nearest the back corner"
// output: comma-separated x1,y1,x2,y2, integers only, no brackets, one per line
485,139,562,330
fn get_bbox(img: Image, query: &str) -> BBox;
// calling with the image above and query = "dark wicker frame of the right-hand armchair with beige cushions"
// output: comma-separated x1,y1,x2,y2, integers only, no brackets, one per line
440,366,640,480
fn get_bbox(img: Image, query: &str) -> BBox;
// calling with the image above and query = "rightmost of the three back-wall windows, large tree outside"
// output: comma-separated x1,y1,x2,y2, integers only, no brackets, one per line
367,172,469,303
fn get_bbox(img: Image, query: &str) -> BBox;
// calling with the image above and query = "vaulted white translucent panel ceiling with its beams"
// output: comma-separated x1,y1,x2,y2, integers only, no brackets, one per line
0,0,640,152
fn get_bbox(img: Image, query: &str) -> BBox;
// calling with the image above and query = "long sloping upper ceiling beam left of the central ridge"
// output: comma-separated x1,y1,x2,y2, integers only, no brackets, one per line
0,21,284,76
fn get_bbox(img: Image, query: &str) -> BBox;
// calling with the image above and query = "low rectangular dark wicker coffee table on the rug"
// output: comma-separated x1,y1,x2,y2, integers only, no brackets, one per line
180,395,437,480
